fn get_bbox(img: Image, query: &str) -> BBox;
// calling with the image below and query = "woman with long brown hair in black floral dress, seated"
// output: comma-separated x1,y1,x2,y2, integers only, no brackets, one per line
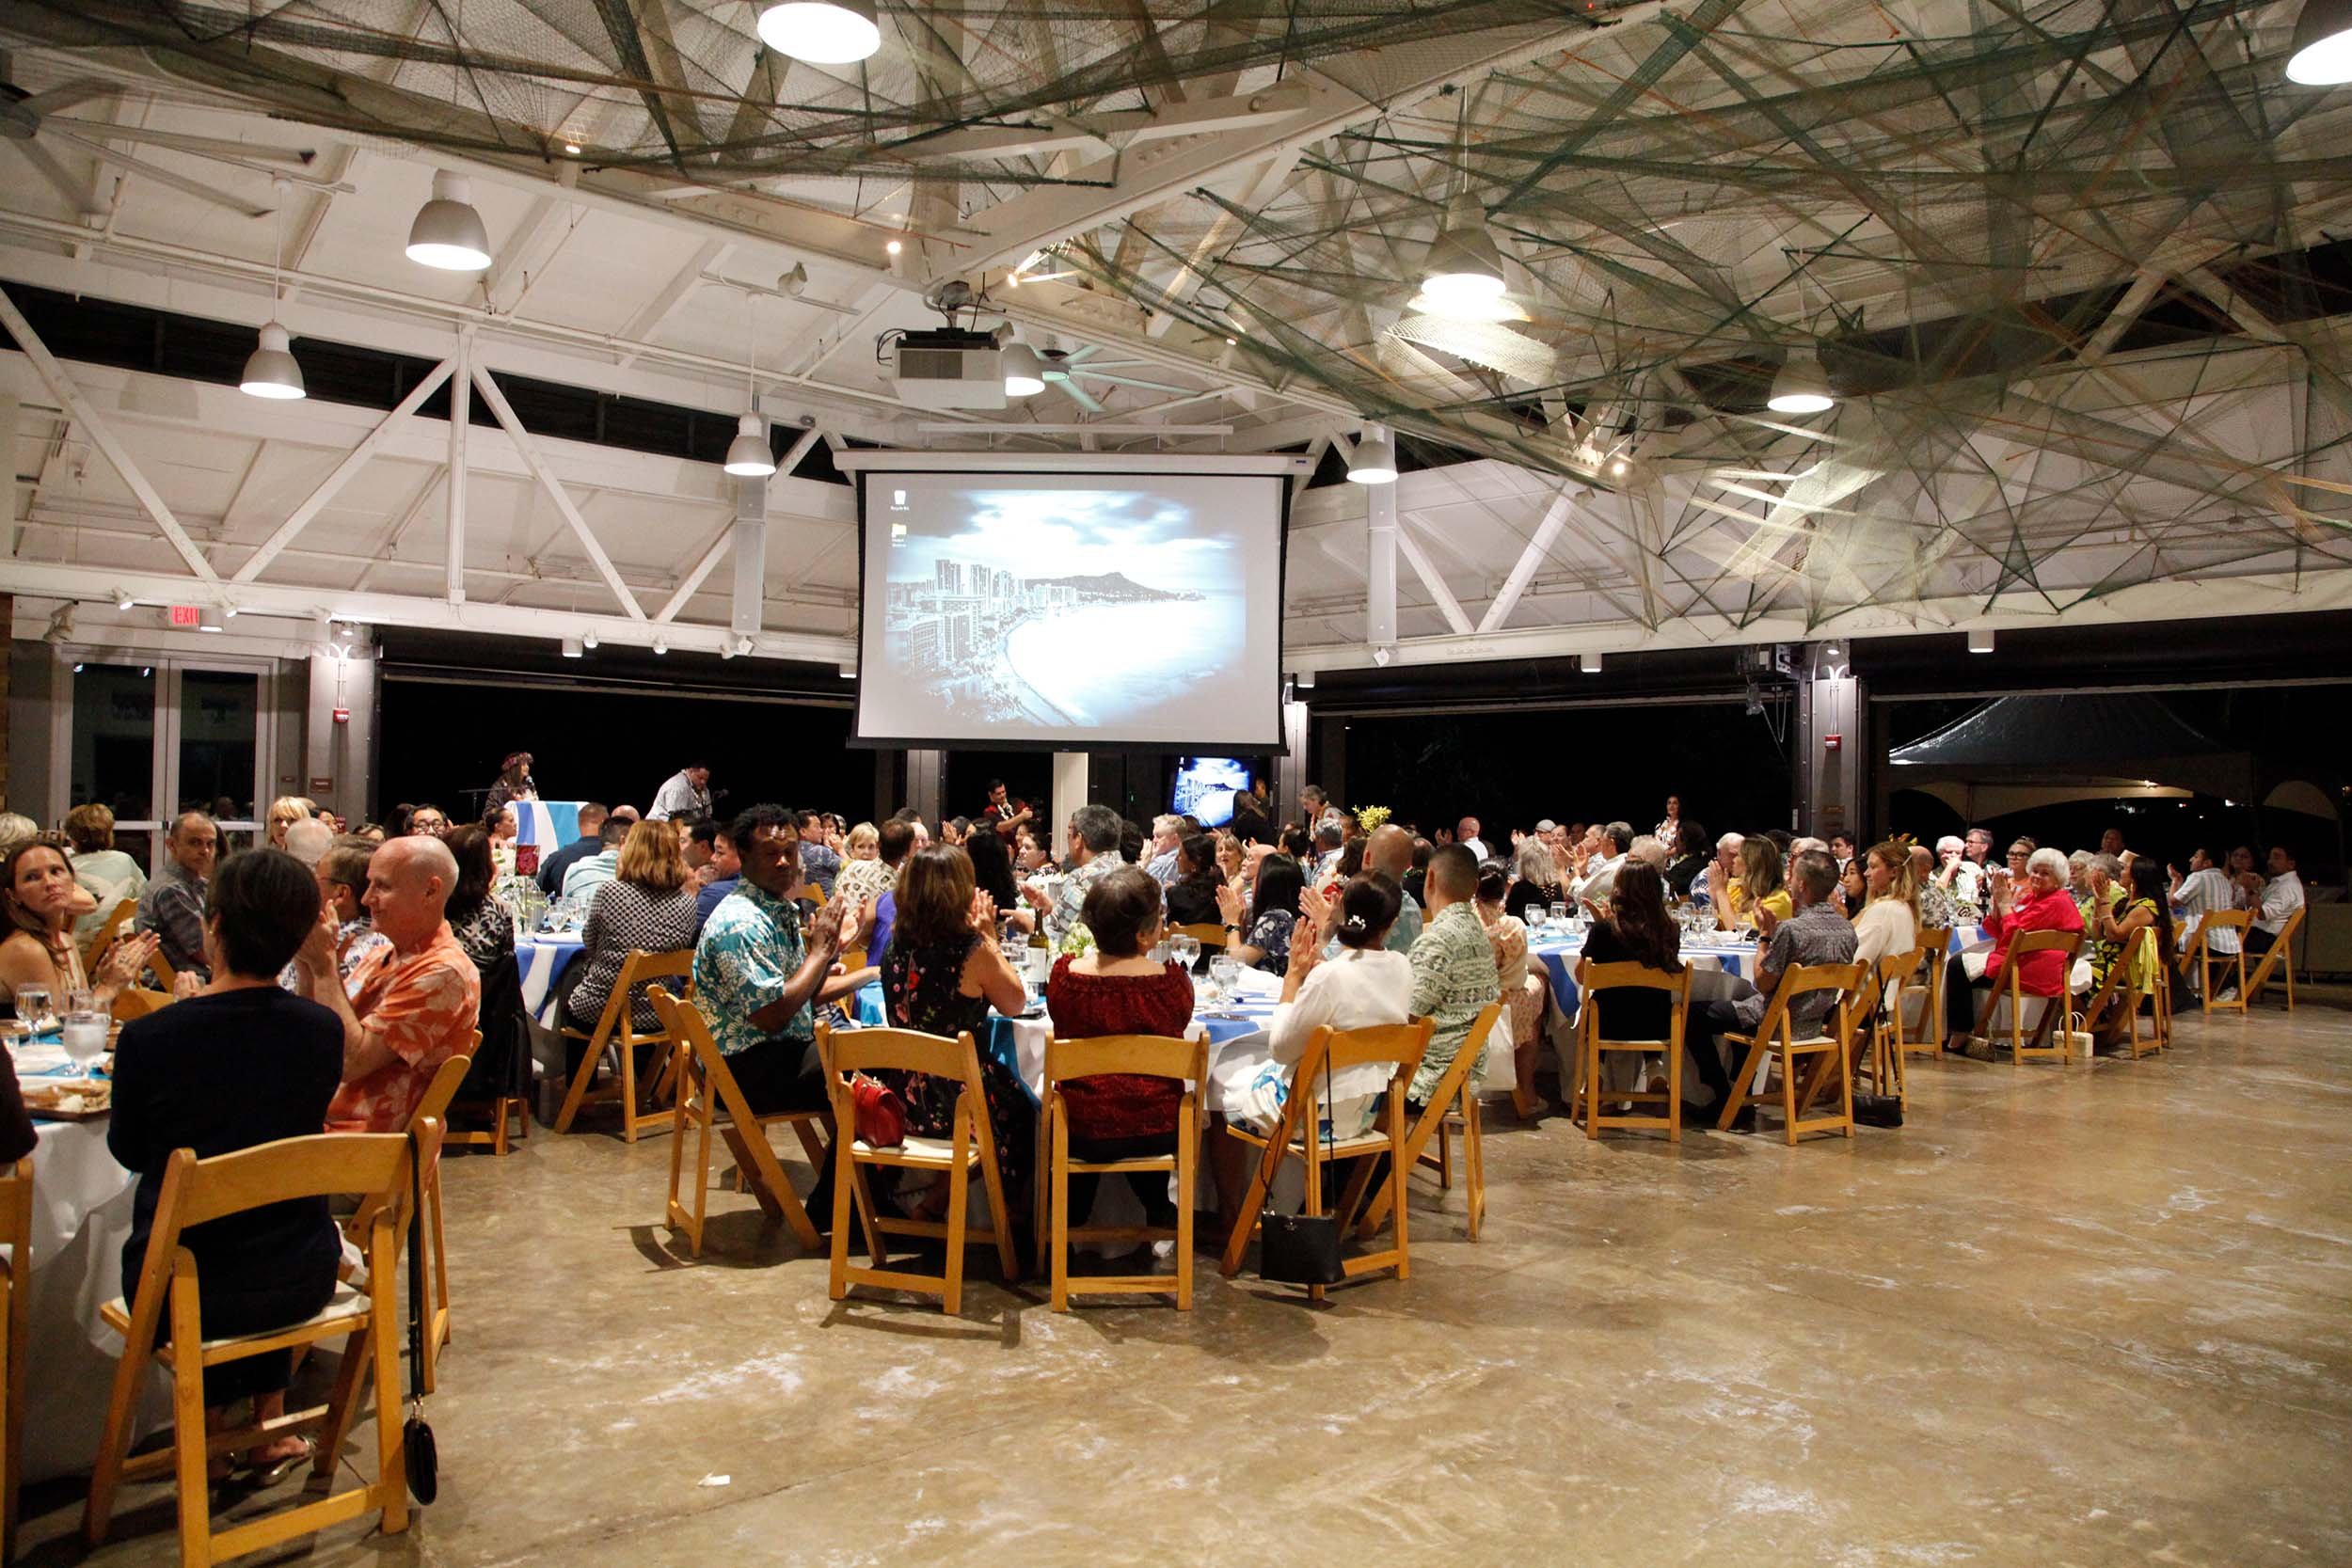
880,832,1035,1218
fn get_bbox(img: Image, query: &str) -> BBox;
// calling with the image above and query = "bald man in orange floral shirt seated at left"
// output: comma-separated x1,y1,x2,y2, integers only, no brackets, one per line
299,837,483,1133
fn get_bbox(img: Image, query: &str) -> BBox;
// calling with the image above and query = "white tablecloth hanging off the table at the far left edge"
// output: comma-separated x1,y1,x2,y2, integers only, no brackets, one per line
17,1046,172,1481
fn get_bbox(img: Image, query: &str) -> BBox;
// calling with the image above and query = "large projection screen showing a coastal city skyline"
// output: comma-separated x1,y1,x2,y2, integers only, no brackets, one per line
856,470,1287,752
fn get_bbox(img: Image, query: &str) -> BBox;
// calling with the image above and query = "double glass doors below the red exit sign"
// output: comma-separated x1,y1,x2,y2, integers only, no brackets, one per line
56,649,276,875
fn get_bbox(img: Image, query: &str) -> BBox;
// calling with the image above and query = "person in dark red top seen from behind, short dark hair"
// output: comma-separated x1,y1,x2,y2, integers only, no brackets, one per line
1044,864,1209,1227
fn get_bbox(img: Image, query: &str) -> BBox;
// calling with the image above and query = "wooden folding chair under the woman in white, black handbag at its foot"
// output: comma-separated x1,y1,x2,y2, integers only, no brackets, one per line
1221,1018,1438,1303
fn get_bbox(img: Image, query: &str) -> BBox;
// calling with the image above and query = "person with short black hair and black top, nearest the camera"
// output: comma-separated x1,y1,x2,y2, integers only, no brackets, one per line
106,848,343,1483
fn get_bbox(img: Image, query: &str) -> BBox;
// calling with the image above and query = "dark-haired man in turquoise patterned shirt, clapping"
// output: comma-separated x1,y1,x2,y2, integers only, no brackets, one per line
694,806,856,1123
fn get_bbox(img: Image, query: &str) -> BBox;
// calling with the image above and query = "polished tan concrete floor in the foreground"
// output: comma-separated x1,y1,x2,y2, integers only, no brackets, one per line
24,999,2352,1568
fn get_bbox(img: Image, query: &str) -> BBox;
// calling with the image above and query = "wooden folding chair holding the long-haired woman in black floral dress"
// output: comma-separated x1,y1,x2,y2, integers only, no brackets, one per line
817,1025,1021,1317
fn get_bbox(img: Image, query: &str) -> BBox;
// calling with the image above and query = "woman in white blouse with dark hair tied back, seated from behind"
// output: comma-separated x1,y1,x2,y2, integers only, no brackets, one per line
1212,872,1414,1225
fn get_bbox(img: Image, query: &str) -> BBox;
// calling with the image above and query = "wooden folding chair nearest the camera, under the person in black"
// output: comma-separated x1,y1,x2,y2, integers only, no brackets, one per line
83,1119,440,1568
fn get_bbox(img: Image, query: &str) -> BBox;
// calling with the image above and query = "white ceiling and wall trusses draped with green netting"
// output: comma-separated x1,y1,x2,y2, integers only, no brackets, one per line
0,0,2352,670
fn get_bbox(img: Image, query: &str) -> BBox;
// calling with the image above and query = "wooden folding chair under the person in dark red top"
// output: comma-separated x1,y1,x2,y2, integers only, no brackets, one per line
1038,1035,1209,1312
